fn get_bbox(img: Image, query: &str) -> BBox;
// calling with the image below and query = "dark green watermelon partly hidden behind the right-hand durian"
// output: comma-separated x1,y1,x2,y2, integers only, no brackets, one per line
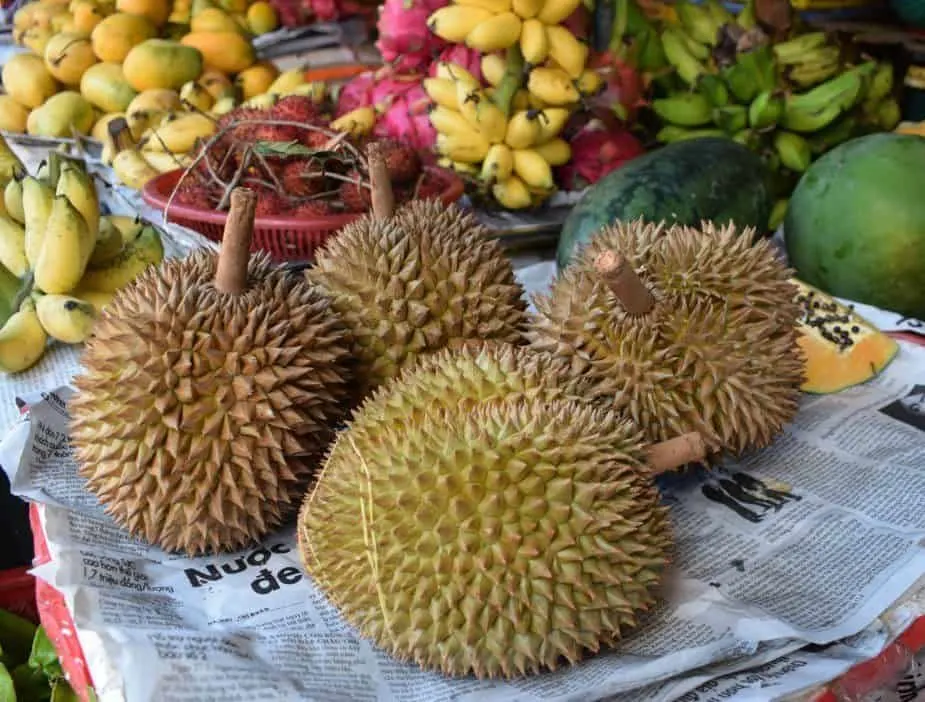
556,137,774,270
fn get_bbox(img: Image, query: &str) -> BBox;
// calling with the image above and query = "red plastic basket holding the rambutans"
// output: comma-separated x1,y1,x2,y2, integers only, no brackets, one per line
142,166,464,262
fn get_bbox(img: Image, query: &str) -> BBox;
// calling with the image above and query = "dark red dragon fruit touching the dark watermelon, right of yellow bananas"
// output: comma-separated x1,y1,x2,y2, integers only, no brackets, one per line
556,119,644,190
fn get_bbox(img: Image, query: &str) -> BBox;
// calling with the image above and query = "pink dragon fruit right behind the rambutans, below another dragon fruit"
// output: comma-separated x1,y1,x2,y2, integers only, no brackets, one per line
337,67,437,150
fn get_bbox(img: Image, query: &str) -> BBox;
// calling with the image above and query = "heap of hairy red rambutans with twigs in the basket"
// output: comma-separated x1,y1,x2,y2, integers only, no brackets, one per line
160,95,452,217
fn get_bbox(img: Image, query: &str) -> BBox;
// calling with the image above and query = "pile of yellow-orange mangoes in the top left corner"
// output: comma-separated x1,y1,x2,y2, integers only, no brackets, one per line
0,0,277,138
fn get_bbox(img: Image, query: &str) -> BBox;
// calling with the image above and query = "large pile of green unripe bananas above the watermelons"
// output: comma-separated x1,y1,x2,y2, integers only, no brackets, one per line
632,0,900,222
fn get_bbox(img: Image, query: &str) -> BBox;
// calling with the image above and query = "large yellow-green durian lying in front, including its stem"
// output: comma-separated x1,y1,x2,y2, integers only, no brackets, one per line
298,344,704,678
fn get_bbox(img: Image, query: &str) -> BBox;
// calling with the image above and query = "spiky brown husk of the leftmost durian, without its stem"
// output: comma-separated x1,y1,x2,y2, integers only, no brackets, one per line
68,252,349,554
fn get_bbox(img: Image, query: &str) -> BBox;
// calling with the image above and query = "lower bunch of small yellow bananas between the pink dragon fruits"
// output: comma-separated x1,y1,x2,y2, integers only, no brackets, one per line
424,63,571,210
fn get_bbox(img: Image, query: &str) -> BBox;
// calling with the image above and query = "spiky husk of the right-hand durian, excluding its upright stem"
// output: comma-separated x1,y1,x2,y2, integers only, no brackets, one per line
527,221,804,457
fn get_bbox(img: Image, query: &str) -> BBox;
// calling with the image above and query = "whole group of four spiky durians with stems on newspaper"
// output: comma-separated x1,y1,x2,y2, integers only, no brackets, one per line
70,147,803,678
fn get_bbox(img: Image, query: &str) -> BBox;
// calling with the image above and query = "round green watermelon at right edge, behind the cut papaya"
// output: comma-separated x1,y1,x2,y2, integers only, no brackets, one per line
784,133,925,319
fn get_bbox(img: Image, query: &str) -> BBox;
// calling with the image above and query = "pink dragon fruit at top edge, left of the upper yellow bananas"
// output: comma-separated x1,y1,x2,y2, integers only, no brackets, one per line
376,0,449,71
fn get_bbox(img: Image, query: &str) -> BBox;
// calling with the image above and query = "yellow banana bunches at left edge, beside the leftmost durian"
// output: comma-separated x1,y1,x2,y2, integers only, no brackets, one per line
0,153,164,373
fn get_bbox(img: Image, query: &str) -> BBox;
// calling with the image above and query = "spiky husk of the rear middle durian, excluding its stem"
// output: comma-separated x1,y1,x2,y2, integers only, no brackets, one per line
306,200,526,404
